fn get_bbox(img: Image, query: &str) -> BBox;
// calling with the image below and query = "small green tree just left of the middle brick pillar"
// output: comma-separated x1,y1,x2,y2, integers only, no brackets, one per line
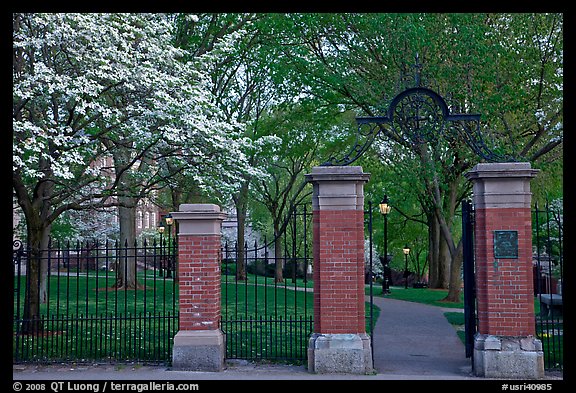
252,99,340,282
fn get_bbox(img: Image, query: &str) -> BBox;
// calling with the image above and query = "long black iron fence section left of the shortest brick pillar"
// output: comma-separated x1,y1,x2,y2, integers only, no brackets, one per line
12,238,178,364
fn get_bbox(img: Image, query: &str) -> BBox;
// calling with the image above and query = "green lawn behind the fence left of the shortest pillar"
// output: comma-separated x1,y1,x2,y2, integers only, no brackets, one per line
13,272,178,362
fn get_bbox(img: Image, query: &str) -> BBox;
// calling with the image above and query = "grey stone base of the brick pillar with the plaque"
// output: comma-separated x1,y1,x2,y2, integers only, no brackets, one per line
474,334,544,379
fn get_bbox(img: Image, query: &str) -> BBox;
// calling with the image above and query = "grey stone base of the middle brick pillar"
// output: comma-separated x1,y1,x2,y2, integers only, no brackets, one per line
308,333,374,374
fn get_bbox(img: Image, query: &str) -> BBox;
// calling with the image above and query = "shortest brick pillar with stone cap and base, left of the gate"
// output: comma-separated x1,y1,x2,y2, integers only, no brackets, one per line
171,204,226,371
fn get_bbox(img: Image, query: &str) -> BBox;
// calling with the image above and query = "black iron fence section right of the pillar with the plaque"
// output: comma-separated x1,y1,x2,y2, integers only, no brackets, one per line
532,203,564,370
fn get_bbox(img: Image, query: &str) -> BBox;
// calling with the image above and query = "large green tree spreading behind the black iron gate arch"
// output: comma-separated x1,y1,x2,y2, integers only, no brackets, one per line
260,13,563,300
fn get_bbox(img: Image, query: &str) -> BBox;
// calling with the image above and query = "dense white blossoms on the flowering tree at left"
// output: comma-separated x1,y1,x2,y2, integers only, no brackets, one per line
13,13,256,199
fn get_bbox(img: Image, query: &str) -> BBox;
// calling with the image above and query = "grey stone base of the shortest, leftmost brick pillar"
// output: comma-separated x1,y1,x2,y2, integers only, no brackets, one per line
172,330,226,371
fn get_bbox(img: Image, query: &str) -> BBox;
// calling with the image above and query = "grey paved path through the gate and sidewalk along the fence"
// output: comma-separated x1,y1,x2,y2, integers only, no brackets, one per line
12,296,564,381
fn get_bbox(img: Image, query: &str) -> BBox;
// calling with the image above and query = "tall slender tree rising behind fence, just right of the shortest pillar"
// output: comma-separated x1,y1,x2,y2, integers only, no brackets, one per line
173,13,282,280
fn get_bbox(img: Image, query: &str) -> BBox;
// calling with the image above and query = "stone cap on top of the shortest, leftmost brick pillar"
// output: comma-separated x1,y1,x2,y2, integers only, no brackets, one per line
170,203,227,235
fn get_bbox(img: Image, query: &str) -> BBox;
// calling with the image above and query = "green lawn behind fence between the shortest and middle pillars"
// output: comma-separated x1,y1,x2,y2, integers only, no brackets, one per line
222,276,380,364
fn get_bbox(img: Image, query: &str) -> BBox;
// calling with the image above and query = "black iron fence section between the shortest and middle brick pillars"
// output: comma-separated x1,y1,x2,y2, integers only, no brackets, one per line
221,206,313,363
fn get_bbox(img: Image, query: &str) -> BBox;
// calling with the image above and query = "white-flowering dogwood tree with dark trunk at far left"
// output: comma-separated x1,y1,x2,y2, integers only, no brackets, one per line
13,13,249,332
